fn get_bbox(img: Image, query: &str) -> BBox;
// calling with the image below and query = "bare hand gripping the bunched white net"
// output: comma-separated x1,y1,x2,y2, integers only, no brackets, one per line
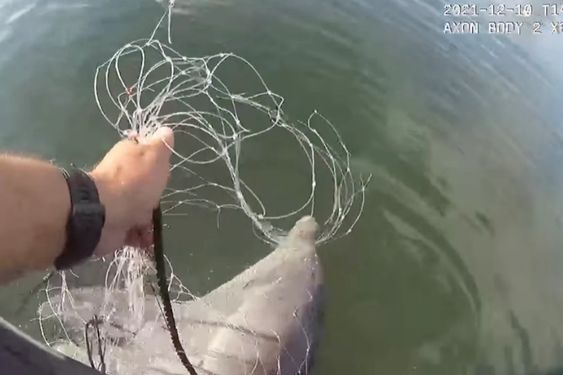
90,127,174,256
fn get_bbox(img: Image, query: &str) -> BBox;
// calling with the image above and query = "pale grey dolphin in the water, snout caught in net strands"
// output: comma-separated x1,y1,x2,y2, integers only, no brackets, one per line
46,216,323,375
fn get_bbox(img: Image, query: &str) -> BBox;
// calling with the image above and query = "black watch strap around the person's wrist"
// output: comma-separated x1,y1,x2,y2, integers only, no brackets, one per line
55,168,105,270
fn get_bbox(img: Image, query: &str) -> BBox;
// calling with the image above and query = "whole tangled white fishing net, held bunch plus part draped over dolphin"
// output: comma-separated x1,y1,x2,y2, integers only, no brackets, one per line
39,3,368,374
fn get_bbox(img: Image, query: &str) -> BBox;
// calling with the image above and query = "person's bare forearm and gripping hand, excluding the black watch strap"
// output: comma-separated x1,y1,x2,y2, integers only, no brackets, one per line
0,128,173,282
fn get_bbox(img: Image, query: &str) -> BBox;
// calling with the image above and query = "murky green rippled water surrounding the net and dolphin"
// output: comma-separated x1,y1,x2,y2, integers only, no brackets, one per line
0,0,563,375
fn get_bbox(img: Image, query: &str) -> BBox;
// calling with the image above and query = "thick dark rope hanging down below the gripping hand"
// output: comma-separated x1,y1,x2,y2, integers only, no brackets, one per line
152,207,197,375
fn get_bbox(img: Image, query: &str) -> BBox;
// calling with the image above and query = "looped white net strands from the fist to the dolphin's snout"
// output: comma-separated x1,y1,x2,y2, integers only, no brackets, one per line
95,45,369,245
